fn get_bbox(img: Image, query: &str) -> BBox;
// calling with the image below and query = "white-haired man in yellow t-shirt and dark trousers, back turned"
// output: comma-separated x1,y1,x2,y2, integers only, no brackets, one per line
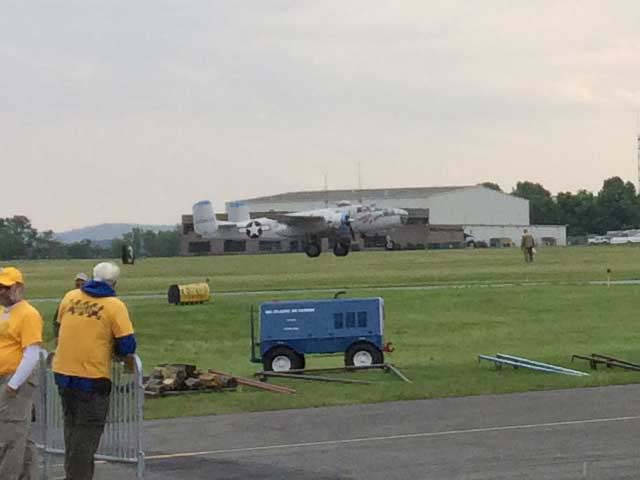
53,262,136,480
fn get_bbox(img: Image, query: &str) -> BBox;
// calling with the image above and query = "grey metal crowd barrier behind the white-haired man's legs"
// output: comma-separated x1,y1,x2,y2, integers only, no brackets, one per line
33,354,145,480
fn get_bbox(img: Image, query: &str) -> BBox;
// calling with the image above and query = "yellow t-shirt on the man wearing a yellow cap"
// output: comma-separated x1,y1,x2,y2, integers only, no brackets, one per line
0,300,43,376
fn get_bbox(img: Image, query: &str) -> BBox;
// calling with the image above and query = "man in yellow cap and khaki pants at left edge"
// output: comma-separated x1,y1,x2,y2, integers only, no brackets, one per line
0,267,43,480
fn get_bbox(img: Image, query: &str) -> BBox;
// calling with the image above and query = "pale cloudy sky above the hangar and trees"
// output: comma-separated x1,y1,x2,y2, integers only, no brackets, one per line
0,0,640,231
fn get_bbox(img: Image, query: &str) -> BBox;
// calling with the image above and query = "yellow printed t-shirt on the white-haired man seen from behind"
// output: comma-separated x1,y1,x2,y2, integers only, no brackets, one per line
53,290,133,378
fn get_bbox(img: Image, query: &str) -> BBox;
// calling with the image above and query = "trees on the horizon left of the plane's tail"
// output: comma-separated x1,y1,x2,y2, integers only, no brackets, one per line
0,215,180,260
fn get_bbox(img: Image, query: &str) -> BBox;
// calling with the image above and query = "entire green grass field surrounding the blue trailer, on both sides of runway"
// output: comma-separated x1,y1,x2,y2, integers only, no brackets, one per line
13,247,640,418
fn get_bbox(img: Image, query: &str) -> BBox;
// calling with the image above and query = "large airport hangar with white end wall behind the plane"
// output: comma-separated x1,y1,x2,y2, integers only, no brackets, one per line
180,185,567,255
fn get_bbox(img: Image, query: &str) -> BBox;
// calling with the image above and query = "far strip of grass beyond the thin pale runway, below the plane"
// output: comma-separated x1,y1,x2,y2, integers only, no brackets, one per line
13,246,640,297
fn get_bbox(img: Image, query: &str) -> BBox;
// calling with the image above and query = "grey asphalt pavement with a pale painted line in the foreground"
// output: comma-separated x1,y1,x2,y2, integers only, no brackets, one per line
46,385,640,480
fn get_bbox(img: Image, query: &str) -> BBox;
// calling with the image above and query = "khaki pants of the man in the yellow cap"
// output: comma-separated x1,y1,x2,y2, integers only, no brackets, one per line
0,376,38,480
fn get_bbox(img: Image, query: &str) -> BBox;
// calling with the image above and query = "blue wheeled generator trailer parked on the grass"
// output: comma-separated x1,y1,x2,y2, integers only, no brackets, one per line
251,297,385,372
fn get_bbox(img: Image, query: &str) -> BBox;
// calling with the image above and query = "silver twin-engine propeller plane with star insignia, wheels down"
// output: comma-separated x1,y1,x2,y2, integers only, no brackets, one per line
193,200,409,257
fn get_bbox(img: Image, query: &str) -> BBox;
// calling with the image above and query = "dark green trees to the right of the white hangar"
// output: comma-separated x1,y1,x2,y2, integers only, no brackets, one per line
482,177,640,236
